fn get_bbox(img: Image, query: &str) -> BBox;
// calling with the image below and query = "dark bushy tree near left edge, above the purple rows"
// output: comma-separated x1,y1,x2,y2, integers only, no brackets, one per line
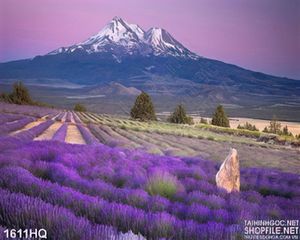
8,82,33,104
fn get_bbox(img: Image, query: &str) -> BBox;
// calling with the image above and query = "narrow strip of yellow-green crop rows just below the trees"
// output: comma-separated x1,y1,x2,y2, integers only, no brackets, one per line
80,113,296,147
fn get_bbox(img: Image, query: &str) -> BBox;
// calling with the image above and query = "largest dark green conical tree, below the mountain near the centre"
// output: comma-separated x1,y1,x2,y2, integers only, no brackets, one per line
130,92,156,121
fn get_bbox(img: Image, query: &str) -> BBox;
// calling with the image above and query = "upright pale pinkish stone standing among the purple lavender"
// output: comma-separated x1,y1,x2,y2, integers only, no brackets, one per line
216,148,240,193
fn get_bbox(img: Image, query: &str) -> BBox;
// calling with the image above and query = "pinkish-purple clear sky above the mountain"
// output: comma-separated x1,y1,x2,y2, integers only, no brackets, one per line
0,0,300,79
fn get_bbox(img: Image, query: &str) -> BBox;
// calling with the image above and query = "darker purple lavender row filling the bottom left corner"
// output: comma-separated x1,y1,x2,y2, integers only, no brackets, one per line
0,189,142,240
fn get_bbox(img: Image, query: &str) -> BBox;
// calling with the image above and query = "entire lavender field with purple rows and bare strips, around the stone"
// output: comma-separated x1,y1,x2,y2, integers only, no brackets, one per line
0,104,300,240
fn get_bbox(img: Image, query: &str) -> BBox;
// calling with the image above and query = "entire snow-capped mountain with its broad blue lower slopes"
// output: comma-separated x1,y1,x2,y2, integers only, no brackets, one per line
0,17,300,120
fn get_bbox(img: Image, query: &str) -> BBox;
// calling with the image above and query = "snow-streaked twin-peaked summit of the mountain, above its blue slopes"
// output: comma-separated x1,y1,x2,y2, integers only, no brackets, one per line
48,17,199,59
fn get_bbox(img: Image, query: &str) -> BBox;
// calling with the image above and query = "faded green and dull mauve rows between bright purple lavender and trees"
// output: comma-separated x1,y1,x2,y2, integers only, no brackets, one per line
79,113,300,173
